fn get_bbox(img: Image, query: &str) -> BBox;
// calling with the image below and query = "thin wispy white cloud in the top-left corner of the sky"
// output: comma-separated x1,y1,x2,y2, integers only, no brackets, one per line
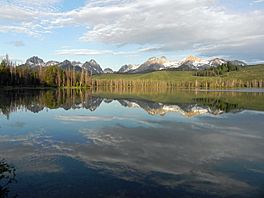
0,0,57,36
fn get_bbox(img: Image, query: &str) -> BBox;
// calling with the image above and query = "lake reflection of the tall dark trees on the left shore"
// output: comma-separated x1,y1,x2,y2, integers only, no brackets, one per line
0,88,97,119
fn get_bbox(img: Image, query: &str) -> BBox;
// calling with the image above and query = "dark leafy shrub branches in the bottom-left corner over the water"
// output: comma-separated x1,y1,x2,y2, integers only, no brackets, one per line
0,160,16,198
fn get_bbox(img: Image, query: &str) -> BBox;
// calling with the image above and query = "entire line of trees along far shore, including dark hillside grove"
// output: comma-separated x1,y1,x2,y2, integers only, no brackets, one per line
0,59,264,88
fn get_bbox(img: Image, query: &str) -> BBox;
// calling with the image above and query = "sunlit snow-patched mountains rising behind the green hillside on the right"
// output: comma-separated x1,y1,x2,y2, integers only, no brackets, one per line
118,56,247,73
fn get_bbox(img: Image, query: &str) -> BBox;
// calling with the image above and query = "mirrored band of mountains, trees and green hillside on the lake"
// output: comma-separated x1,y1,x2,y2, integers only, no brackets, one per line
0,89,264,117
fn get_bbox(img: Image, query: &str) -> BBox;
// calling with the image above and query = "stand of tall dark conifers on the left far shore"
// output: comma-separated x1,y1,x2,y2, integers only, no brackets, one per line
0,60,92,87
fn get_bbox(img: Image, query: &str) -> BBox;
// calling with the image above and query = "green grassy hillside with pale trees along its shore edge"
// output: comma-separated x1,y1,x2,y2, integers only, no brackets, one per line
93,65,264,90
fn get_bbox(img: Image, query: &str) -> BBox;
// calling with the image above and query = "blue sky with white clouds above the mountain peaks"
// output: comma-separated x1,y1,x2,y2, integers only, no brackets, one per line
0,0,264,70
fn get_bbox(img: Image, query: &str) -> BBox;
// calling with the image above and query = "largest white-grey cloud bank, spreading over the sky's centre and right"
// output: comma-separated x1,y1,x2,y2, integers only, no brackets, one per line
53,0,264,58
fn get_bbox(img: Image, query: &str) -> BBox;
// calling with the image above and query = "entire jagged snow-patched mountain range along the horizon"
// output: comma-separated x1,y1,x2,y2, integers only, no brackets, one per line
20,56,247,74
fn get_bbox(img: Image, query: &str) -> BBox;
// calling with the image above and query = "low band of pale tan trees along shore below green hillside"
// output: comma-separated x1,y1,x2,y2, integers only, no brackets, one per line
92,78,264,91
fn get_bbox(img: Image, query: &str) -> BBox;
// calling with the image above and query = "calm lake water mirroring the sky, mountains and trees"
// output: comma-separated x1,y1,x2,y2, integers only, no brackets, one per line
0,90,264,198
